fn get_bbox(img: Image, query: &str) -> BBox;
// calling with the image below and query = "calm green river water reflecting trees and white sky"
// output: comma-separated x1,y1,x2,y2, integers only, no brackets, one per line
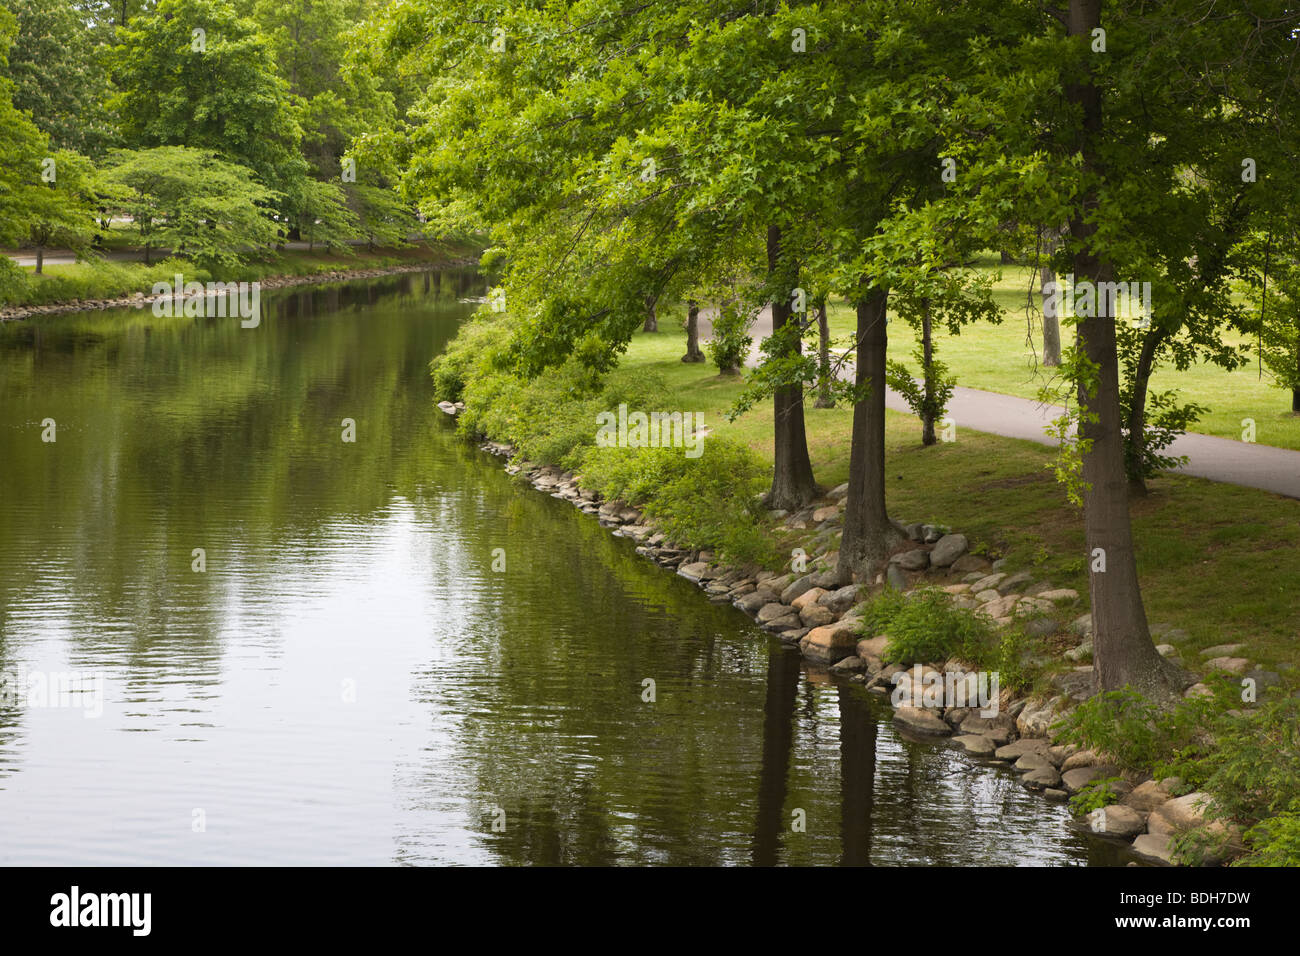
0,273,1118,865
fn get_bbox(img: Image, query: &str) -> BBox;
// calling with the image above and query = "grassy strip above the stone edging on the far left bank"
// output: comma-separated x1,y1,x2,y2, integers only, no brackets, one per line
0,242,477,307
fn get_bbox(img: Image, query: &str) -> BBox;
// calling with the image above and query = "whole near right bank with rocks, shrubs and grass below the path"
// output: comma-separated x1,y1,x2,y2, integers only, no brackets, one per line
430,308,1300,865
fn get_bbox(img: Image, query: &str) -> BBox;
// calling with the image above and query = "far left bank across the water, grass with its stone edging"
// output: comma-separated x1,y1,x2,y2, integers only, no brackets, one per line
0,243,478,321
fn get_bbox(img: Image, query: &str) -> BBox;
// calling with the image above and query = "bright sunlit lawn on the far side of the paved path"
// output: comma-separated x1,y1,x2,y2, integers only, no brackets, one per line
827,263,1300,451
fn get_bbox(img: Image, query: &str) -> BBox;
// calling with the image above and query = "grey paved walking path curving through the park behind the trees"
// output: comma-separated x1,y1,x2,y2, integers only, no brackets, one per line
699,308,1300,498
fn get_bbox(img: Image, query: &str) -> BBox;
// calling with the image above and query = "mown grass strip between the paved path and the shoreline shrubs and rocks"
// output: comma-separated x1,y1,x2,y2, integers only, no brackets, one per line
615,323,1300,671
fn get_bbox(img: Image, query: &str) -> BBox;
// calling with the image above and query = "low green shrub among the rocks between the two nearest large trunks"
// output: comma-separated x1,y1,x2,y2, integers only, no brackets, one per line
862,588,992,663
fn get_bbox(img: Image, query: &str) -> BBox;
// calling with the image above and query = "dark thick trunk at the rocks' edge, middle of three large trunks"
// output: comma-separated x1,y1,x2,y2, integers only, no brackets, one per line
835,289,904,584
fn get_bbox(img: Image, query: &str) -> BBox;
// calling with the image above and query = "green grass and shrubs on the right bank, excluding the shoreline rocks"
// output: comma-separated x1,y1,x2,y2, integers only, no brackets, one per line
434,319,1300,865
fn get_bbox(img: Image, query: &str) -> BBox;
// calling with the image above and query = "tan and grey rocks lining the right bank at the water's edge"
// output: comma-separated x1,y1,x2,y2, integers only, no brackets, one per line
439,402,1266,865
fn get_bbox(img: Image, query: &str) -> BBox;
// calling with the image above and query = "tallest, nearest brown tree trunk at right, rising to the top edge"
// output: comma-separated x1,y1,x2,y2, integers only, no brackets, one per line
1066,0,1183,700
